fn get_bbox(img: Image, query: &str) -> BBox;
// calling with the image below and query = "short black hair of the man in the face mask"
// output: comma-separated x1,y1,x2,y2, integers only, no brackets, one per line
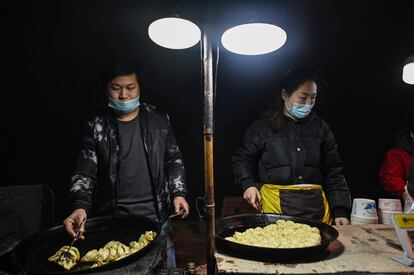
102,58,142,85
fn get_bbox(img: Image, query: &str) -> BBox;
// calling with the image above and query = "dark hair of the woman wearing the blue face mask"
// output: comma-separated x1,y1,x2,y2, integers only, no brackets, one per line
264,69,325,131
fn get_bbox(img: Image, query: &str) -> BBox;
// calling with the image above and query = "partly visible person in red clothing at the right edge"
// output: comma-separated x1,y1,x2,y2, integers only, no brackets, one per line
379,119,414,199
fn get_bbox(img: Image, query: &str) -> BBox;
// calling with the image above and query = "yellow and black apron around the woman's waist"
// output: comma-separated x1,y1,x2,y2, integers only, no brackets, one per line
260,184,332,224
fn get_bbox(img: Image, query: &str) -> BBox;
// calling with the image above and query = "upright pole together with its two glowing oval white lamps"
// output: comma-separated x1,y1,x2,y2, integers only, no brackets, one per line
148,5,287,275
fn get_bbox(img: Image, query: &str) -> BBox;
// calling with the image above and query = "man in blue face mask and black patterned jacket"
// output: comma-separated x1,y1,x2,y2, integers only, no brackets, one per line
64,59,189,267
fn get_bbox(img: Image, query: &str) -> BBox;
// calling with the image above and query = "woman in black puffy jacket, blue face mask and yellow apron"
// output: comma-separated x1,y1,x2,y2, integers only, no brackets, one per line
232,71,351,225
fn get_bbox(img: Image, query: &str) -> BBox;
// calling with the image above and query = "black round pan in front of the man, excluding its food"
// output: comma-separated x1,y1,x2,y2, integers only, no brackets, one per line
11,216,160,275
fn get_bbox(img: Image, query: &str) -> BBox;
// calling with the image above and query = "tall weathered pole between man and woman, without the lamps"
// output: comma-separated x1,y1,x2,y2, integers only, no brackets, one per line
202,26,217,275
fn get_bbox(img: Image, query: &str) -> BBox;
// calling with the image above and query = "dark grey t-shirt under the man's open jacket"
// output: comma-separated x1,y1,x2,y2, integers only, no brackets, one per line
116,116,157,219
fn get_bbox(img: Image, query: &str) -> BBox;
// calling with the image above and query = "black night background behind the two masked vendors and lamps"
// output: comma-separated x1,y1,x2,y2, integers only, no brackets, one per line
1,0,414,224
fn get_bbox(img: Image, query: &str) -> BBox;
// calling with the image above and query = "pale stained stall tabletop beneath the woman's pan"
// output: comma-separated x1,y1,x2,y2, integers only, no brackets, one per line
215,224,414,274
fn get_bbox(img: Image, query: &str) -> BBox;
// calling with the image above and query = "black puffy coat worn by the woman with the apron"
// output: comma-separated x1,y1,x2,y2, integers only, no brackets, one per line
232,114,351,218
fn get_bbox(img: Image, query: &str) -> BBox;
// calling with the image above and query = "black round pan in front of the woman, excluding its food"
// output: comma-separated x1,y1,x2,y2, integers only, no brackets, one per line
216,214,338,262
